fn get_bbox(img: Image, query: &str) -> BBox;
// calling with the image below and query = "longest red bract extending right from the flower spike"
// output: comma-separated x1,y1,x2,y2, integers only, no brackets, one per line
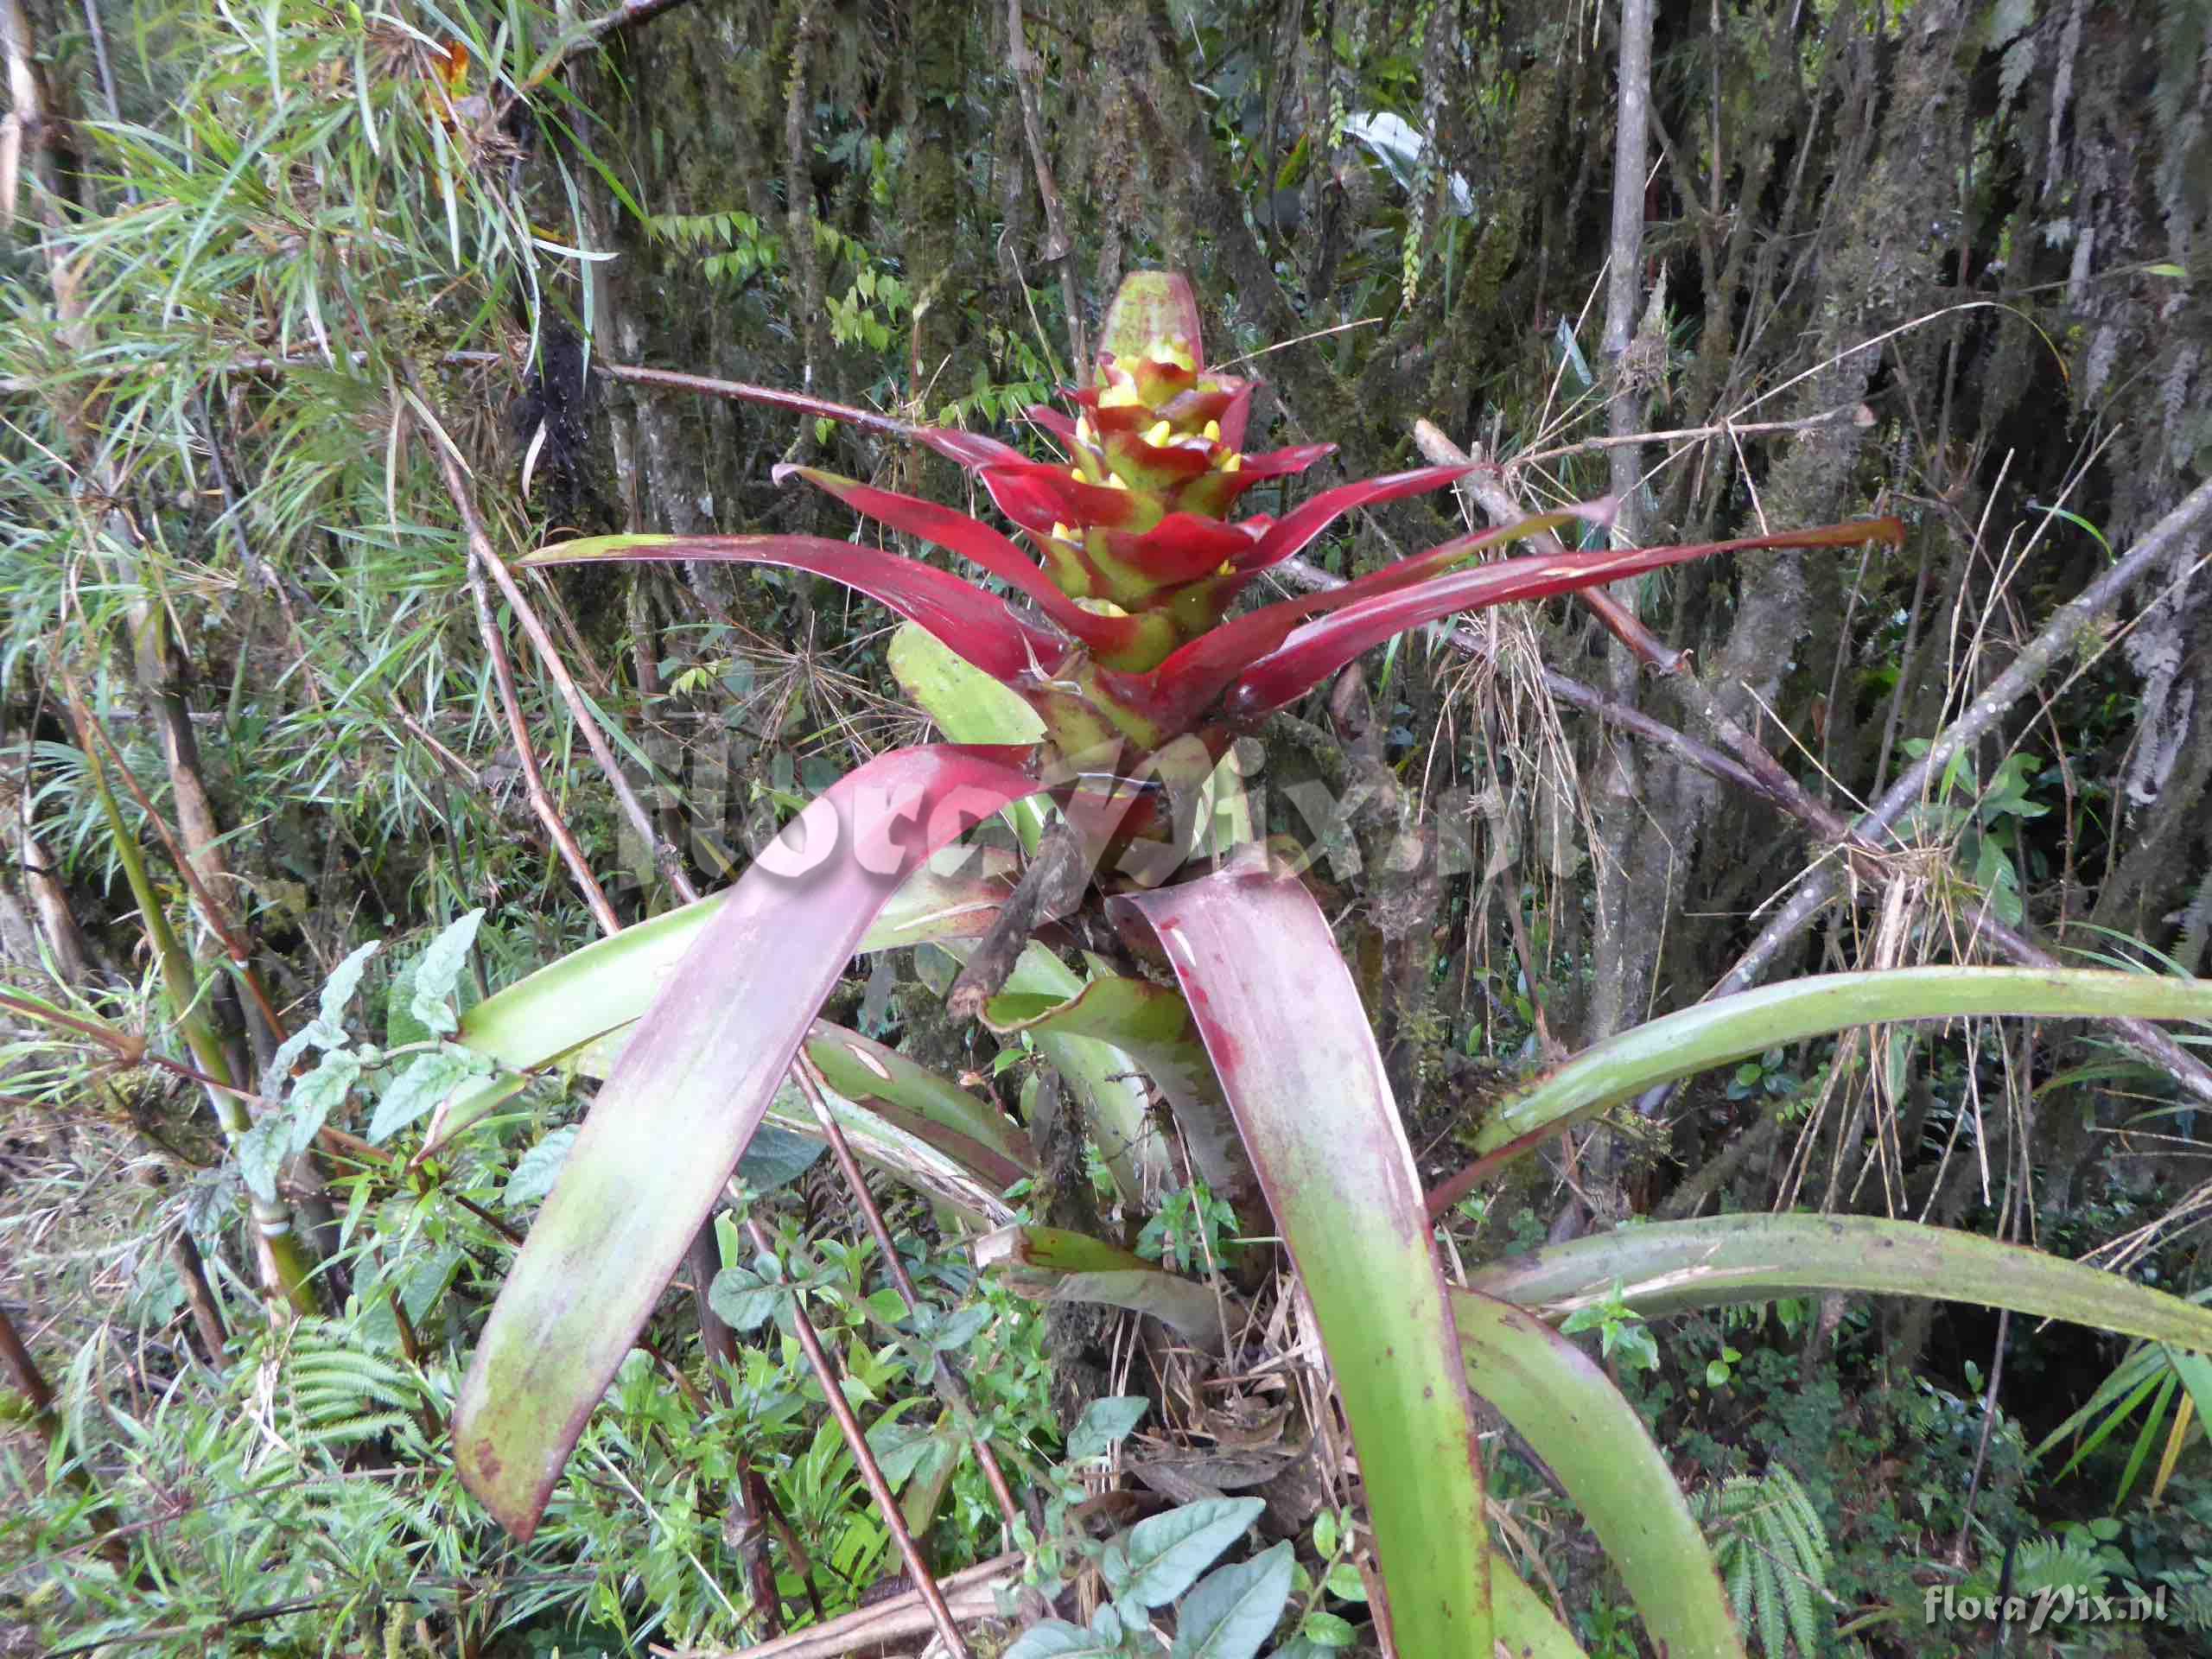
1221,518,1903,716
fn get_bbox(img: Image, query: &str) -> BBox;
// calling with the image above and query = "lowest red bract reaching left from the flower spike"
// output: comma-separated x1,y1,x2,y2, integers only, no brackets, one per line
522,536,1066,681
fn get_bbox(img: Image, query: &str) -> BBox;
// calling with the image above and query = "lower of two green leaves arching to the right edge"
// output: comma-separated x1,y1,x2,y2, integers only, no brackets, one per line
1471,1211,2212,1351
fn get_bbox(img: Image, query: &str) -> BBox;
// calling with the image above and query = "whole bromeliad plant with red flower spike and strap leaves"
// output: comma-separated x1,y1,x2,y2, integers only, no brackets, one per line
448,274,2212,1659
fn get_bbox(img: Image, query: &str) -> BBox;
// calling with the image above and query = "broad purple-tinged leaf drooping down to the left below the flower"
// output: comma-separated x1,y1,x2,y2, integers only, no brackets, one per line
454,746,1038,1540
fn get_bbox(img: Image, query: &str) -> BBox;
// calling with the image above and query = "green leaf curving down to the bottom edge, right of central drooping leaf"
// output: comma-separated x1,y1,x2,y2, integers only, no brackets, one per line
1451,1292,1743,1659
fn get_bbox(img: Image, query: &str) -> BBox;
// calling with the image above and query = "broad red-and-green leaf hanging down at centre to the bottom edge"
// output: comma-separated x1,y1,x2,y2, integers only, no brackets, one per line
1123,865,1491,1659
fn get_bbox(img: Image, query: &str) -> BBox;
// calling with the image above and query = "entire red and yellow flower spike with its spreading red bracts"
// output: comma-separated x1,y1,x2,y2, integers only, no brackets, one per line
533,272,1903,759
